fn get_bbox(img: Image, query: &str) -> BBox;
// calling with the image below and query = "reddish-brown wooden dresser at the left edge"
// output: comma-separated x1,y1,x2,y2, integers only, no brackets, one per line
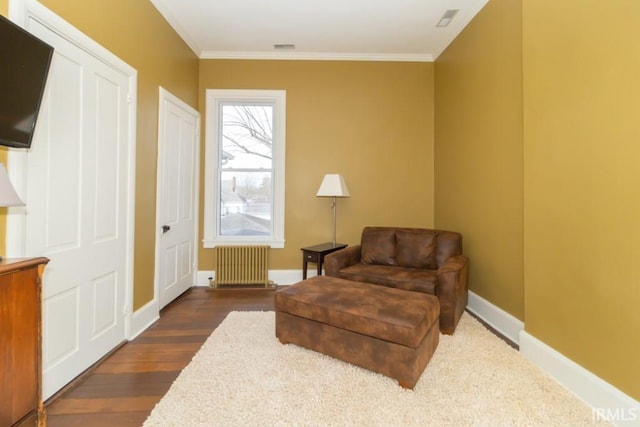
0,258,49,426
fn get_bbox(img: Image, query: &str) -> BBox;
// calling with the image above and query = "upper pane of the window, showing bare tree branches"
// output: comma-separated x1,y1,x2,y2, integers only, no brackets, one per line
220,104,273,169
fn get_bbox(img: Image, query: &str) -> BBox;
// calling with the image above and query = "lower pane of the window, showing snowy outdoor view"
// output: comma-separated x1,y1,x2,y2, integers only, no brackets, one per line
220,171,272,236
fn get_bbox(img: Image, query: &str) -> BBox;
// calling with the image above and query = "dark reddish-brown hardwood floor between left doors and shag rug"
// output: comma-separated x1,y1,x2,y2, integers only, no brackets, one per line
46,287,274,427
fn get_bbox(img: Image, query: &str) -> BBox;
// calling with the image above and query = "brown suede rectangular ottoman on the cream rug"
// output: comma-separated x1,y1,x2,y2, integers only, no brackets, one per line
275,276,440,389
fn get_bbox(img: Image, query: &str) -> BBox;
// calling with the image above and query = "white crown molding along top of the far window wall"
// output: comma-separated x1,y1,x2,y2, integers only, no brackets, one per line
200,51,434,62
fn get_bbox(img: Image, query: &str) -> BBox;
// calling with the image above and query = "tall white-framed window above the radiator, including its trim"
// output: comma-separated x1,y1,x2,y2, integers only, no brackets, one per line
204,89,286,248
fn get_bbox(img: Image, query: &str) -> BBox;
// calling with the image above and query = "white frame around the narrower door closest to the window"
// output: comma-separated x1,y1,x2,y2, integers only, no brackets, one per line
154,86,200,309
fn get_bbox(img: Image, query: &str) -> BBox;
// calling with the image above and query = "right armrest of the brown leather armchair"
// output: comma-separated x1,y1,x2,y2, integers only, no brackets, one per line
436,255,469,334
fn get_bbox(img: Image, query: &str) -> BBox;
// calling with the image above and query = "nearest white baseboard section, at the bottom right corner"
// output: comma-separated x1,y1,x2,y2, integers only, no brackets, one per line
520,330,640,426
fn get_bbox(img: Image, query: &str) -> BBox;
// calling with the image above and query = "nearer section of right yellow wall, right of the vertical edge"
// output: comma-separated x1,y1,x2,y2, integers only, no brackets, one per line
523,0,640,399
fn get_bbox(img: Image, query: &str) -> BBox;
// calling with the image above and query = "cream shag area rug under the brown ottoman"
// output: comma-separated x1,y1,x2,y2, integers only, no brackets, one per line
144,312,602,427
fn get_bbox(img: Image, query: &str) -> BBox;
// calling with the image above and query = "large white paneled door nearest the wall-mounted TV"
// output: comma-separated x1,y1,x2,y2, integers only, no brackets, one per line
8,0,135,399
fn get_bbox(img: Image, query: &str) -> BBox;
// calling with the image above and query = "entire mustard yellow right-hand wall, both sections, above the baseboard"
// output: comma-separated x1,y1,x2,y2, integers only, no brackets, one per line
435,0,640,399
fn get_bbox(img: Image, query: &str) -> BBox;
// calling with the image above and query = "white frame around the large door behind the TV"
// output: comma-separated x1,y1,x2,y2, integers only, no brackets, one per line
6,0,138,339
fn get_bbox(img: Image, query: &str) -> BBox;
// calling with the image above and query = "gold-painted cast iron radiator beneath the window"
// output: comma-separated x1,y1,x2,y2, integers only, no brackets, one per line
213,245,273,288
